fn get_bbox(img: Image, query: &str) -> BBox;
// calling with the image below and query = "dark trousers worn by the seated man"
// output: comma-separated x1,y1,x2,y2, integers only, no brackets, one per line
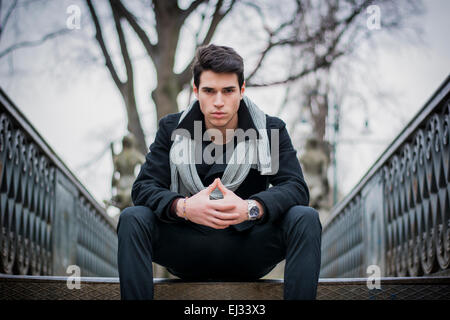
117,206,322,300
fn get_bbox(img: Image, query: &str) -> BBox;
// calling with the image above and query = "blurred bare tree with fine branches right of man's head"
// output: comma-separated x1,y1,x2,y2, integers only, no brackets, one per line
246,0,423,140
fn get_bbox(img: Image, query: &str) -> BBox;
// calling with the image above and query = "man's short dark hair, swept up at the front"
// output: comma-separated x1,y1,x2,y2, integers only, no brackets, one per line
192,44,244,88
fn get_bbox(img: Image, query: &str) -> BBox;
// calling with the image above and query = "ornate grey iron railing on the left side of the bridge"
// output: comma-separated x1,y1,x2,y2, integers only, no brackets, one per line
0,89,118,277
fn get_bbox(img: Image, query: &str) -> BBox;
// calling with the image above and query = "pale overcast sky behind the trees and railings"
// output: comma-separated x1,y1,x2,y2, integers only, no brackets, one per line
0,0,450,216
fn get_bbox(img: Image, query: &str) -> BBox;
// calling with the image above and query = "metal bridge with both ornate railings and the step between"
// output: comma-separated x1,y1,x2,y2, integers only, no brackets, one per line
0,77,450,300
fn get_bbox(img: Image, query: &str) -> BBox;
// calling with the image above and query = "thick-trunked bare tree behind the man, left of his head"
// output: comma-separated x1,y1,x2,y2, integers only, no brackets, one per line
86,0,239,153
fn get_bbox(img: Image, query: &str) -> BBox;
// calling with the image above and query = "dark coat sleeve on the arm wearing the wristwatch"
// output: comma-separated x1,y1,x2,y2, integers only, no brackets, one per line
250,117,309,223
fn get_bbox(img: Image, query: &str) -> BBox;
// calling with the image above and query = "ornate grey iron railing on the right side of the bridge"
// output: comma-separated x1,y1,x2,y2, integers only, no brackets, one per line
320,77,450,277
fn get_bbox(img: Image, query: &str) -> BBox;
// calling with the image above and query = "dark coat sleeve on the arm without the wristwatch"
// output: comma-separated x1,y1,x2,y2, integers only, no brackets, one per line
131,114,184,222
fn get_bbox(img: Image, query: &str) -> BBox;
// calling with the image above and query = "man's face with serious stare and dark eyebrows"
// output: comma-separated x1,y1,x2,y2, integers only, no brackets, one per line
194,70,245,130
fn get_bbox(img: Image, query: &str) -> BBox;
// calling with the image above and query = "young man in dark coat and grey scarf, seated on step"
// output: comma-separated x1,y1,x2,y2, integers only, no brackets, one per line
117,45,322,299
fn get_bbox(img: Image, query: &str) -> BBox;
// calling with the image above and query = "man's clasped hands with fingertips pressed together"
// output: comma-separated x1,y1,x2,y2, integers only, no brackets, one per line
177,178,248,229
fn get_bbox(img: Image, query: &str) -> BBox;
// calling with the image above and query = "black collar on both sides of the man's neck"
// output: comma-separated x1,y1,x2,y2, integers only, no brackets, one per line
176,100,260,138
